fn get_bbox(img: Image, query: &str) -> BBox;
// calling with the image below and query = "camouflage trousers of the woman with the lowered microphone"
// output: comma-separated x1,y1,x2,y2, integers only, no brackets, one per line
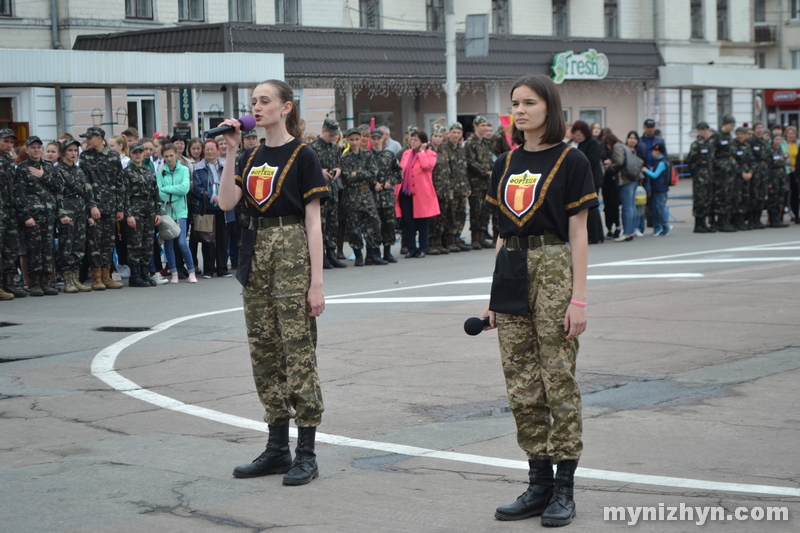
497,245,583,463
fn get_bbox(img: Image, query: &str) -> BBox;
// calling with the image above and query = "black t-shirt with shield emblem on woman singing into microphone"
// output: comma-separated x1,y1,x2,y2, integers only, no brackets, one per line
236,139,331,218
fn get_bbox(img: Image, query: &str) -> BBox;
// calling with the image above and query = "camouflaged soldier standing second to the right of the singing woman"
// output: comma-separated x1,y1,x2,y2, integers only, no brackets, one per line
342,128,388,266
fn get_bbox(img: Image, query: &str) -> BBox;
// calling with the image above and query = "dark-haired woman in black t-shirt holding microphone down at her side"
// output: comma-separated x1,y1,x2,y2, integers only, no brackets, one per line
481,75,599,526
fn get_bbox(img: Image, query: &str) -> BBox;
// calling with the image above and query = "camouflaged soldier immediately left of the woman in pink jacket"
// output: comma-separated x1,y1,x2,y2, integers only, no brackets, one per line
370,130,403,263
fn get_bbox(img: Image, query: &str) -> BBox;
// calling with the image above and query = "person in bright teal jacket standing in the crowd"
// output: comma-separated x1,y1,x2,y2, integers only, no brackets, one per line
156,144,197,283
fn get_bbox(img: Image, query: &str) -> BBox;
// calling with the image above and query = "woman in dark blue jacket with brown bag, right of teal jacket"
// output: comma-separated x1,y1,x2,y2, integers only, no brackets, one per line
192,139,233,279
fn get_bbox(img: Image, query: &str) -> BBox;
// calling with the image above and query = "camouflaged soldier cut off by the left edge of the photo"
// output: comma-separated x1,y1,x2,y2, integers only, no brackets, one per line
0,128,27,300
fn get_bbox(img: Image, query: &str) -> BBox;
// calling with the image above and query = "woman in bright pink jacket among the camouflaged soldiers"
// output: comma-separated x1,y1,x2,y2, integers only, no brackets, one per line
395,131,439,259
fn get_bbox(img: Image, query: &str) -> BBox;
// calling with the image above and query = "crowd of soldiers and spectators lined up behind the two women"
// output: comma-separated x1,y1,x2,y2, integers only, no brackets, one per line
0,108,798,300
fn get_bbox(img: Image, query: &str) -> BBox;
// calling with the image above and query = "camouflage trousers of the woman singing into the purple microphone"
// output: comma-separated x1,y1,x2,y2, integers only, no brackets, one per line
242,224,325,427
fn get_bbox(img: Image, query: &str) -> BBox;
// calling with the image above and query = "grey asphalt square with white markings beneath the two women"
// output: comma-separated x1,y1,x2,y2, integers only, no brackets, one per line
0,183,800,533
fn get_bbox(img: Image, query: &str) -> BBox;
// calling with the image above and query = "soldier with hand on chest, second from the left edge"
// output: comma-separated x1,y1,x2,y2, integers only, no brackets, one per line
15,135,61,296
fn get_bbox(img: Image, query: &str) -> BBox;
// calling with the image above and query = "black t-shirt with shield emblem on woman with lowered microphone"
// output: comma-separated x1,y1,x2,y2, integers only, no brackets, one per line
486,143,599,242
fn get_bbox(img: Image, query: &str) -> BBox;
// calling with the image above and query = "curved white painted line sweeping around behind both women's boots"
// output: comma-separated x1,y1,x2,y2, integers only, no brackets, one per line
91,307,800,497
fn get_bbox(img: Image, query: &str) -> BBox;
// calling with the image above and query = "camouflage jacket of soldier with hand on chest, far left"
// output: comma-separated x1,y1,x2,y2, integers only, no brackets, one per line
15,158,61,219
